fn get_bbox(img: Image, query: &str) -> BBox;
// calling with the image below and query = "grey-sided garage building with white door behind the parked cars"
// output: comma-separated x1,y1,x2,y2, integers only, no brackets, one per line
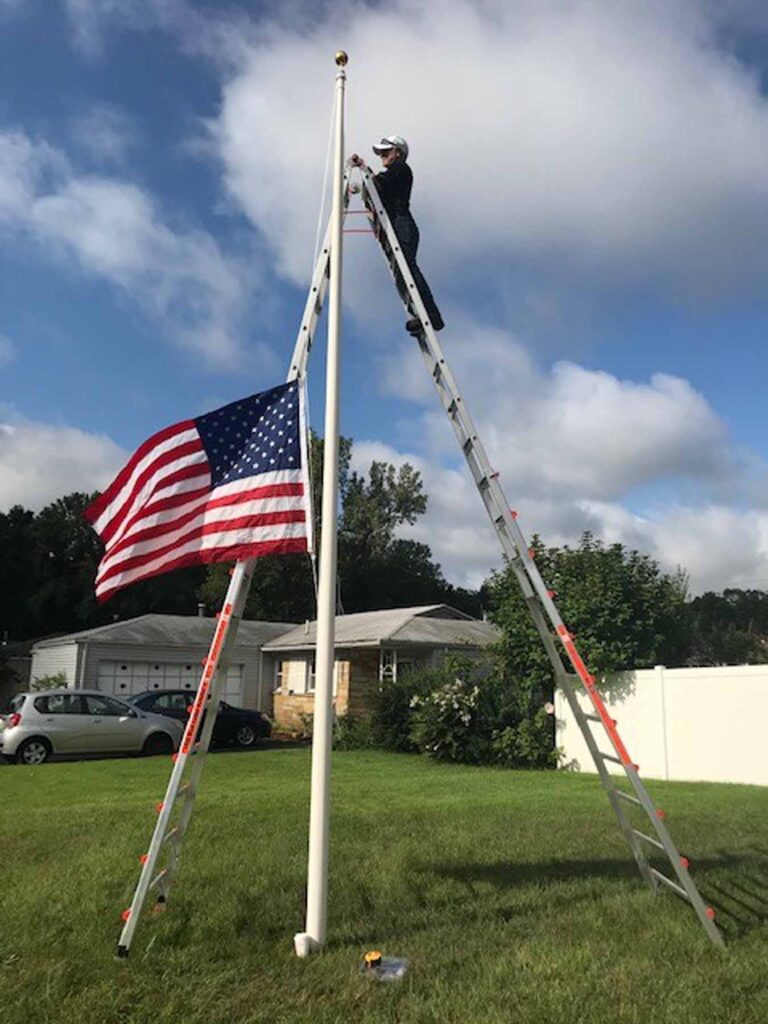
31,614,293,714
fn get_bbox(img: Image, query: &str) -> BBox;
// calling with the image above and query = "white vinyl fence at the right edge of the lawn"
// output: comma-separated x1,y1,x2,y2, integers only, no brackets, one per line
555,665,768,782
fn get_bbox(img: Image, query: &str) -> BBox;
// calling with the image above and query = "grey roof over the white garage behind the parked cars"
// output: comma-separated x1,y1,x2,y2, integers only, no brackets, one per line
32,614,294,651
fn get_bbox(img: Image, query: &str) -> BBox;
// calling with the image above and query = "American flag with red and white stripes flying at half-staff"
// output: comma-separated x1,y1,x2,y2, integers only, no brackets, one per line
85,381,311,601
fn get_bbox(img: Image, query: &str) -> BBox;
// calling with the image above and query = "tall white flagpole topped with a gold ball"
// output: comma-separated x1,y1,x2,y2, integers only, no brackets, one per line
294,51,347,956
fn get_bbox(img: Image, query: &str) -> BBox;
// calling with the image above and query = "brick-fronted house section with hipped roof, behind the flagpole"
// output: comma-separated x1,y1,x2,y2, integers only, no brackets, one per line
264,604,500,729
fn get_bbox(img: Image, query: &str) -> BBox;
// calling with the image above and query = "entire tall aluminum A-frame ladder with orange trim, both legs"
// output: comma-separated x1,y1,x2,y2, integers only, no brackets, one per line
117,157,724,957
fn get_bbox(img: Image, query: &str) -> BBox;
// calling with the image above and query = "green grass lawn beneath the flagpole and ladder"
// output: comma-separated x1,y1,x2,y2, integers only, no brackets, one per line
0,749,768,1024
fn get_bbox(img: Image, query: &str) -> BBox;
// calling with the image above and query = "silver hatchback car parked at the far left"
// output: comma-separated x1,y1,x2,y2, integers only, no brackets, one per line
0,689,183,765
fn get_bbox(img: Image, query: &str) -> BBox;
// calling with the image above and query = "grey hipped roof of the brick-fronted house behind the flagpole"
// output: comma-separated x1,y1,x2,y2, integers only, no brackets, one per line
264,604,500,651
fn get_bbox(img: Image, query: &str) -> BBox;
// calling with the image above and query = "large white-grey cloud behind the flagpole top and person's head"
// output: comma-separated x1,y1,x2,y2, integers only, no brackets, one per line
215,0,768,296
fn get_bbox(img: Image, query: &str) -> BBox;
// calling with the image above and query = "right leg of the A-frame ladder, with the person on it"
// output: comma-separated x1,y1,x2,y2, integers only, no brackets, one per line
359,161,724,946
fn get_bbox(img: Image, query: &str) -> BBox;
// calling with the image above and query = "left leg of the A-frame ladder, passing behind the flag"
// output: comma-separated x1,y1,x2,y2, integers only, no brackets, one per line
117,178,349,957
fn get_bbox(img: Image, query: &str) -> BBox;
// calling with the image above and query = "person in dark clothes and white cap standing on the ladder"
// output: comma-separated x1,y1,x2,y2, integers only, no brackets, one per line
350,135,445,335
